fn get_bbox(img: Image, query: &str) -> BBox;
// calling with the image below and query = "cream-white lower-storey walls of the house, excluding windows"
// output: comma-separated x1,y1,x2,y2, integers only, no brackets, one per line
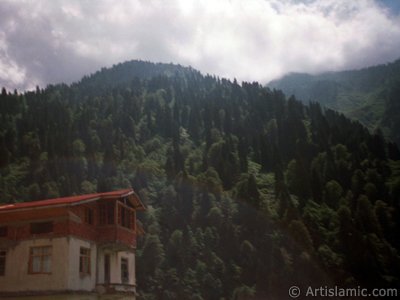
0,237,136,292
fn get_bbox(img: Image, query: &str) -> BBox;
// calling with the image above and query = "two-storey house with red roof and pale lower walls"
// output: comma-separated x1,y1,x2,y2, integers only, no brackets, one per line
0,189,144,299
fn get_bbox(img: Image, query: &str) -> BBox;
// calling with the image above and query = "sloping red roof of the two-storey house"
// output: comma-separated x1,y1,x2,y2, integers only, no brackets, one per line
0,189,141,212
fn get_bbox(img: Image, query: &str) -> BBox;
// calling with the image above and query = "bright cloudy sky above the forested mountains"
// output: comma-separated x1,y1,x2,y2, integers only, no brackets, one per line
0,0,400,91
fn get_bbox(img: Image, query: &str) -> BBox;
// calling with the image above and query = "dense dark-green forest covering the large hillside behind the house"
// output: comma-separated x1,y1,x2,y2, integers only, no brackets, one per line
0,61,400,300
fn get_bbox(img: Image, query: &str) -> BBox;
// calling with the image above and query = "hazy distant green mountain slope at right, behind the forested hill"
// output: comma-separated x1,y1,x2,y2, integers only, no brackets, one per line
268,60,400,145
